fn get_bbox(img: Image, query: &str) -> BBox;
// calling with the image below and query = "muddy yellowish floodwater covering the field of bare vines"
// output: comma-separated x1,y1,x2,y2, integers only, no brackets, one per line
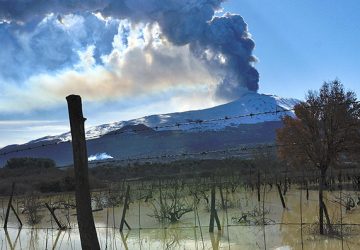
0,185,360,249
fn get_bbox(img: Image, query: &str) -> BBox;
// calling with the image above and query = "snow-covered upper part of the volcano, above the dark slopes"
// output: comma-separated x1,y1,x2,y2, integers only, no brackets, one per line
29,92,299,143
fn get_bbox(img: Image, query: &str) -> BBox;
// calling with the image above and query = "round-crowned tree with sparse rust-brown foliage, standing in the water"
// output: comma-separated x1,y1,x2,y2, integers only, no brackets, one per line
277,80,360,234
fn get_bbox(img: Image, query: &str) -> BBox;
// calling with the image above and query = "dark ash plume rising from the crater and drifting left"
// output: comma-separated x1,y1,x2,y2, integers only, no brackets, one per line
0,0,259,100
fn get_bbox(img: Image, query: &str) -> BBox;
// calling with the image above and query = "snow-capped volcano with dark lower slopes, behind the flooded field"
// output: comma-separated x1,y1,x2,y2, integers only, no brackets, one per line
0,93,299,166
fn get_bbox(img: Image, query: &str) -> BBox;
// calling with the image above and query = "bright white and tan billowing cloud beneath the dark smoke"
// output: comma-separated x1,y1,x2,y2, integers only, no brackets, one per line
0,22,217,112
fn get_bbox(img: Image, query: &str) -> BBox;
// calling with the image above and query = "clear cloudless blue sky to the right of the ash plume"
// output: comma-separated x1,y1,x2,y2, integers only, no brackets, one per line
224,0,360,99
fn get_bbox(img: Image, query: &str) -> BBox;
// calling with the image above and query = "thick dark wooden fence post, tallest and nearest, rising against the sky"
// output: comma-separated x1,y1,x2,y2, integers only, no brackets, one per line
66,95,100,249
